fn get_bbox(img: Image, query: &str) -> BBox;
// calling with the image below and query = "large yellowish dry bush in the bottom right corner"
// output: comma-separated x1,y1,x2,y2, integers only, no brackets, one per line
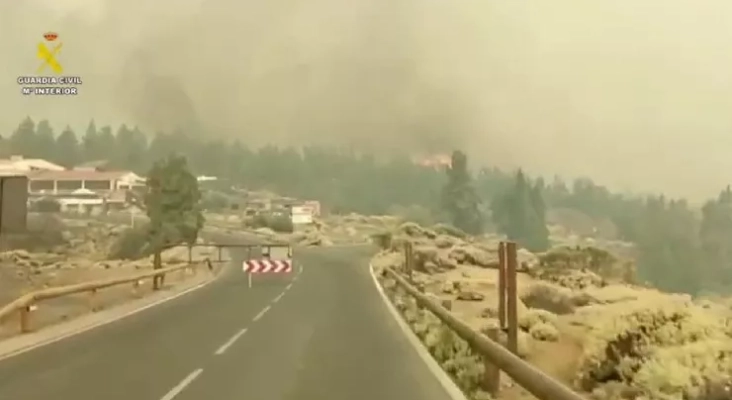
577,296,732,400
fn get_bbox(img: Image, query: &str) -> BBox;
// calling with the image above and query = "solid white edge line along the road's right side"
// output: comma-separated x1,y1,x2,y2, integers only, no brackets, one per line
369,263,468,400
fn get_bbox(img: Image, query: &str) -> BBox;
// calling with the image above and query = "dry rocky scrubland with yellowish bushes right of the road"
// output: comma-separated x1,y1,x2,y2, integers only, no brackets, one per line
373,223,732,400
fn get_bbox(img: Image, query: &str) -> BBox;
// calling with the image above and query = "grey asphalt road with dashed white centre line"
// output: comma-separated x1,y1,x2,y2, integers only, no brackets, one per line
0,248,448,400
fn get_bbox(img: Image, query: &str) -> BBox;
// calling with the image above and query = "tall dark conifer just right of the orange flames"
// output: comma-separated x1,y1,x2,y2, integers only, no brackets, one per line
442,150,483,234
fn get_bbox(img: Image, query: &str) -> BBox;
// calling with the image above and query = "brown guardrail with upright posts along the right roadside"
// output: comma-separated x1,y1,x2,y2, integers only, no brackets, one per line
384,243,586,400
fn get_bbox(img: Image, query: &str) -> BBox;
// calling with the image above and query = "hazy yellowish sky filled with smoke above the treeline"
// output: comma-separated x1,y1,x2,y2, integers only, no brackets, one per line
0,0,732,200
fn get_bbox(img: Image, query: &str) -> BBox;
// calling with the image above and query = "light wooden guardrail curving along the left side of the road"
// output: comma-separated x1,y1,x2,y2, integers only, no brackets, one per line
0,262,213,333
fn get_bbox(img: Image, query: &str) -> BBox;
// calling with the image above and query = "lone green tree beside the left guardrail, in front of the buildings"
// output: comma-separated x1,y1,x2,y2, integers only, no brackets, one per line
144,155,204,288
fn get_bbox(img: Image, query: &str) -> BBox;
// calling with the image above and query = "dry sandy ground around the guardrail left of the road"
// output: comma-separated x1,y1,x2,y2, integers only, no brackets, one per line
0,217,215,337
